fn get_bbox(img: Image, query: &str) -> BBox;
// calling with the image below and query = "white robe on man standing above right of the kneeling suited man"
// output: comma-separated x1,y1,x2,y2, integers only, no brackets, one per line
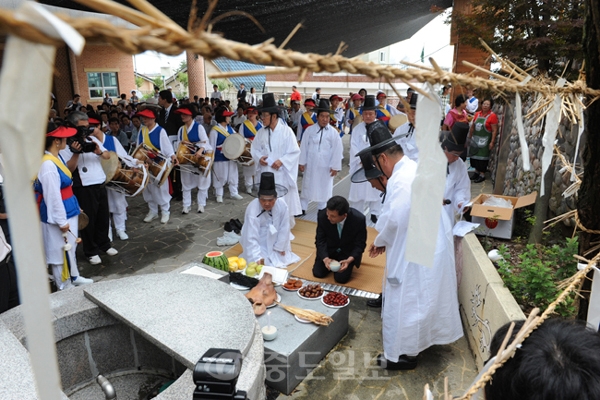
348,122,381,205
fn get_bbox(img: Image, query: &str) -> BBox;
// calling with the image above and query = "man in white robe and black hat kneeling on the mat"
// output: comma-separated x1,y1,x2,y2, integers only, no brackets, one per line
240,172,300,268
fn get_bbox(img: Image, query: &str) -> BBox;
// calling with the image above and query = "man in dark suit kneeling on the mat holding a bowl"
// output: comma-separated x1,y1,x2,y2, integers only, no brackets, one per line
313,196,367,283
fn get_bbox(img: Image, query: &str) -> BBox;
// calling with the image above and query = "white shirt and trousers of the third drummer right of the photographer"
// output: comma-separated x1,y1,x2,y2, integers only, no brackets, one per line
177,121,213,207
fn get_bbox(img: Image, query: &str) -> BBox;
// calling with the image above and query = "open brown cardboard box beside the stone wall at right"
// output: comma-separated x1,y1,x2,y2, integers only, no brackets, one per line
471,192,537,239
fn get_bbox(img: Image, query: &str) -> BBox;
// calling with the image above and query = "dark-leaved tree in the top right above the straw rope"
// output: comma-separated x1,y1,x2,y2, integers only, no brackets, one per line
451,0,585,78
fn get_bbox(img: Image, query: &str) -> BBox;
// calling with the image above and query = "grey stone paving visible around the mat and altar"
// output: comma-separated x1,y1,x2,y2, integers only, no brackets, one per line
72,135,492,400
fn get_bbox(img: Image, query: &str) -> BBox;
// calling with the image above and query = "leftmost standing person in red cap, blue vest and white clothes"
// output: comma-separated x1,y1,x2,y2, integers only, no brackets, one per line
34,123,94,290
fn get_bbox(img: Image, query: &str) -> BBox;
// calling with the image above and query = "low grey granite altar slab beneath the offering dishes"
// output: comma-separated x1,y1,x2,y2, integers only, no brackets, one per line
257,287,352,394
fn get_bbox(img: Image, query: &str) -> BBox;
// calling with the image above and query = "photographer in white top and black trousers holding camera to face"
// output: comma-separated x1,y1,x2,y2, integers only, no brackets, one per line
61,111,118,265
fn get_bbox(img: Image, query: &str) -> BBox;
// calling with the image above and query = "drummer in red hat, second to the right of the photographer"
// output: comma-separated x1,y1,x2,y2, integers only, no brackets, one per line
136,108,178,224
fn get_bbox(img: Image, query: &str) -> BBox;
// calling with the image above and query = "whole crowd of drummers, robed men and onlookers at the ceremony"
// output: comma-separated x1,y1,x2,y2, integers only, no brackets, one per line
0,85,597,398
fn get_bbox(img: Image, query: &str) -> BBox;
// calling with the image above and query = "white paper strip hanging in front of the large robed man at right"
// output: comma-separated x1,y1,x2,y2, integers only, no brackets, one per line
406,83,448,267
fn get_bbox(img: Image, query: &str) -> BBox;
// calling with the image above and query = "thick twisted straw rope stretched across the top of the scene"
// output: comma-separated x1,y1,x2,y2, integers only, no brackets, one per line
0,0,600,101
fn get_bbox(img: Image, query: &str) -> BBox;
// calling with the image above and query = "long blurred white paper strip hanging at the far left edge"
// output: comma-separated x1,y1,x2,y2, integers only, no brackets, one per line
0,2,84,400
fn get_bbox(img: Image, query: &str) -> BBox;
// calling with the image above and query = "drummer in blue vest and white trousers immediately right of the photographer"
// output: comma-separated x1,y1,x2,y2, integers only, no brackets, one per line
90,114,138,241
